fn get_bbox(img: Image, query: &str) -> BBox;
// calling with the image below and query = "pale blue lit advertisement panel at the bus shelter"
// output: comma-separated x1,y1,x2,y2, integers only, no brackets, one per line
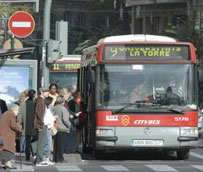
0,60,37,107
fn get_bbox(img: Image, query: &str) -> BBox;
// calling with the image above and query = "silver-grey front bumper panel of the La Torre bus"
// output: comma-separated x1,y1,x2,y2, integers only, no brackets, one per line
95,127,198,150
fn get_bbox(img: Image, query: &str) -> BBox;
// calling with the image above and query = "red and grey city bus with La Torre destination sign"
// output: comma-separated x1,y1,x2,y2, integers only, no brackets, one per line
78,35,198,159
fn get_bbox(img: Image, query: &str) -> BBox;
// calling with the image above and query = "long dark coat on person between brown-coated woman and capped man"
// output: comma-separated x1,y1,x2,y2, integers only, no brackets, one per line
17,99,37,136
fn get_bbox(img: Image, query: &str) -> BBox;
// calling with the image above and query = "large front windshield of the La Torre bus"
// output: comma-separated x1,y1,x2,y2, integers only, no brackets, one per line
96,64,196,109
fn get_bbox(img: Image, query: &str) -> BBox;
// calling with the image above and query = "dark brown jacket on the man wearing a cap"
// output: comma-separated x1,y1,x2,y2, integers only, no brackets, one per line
34,97,45,129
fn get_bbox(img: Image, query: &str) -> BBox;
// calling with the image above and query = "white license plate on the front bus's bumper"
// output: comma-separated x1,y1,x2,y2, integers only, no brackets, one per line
131,140,164,146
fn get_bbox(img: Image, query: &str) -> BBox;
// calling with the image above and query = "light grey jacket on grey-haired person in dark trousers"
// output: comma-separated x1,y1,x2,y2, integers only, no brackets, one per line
54,104,71,133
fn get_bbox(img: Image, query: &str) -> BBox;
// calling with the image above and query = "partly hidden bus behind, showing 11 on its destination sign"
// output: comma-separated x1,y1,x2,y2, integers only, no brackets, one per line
49,55,81,89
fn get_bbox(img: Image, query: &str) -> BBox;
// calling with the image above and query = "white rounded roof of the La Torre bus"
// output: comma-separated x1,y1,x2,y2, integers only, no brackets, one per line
98,34,176,44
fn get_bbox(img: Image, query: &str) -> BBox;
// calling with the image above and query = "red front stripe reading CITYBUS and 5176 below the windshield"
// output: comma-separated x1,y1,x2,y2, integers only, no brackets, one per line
96,111,198,127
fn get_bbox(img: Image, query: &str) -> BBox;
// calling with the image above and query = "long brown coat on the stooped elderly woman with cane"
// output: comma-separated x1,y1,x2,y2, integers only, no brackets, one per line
0,110,21,153
